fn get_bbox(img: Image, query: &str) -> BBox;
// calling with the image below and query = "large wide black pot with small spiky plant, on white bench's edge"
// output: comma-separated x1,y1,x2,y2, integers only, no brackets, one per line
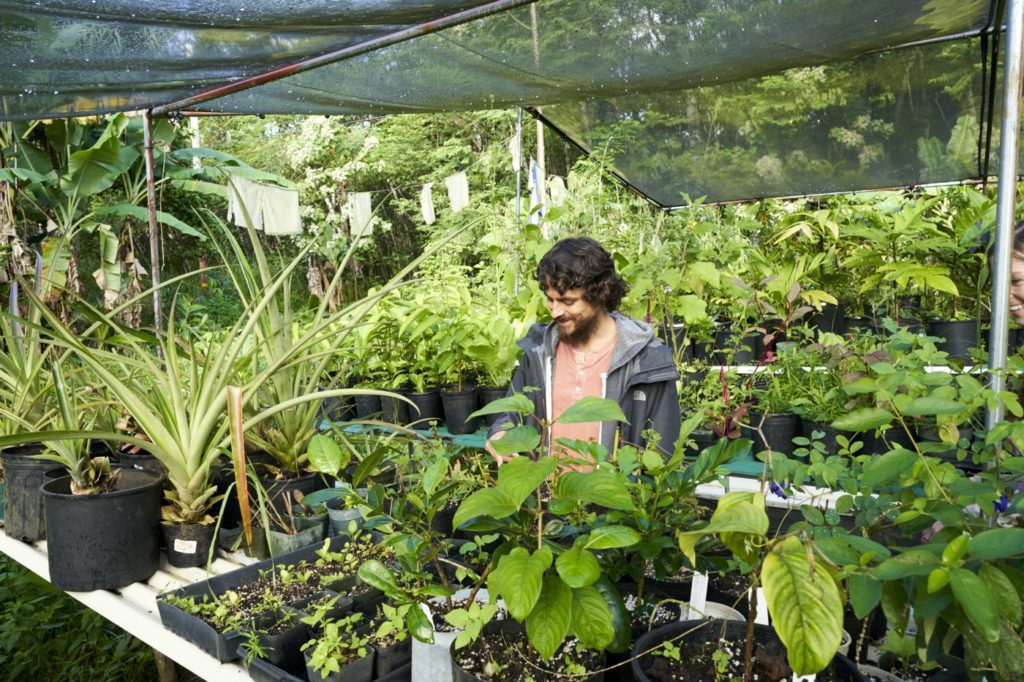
43,469,164,592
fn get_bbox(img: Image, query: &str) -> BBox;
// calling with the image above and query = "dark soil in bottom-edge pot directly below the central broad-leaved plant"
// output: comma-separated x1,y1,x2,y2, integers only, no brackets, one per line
455,630,602,682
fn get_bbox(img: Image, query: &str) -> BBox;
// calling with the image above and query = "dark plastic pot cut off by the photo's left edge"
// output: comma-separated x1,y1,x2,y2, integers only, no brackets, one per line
0,444,55,543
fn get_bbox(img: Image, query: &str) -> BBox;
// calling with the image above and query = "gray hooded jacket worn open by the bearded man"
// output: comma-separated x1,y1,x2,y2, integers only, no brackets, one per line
487,312,680,453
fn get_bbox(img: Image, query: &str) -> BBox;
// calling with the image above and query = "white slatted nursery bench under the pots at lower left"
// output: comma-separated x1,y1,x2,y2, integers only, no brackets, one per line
0,532,255,682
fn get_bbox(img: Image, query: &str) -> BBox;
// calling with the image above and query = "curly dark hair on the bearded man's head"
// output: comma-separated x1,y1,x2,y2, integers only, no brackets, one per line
535,237,630,312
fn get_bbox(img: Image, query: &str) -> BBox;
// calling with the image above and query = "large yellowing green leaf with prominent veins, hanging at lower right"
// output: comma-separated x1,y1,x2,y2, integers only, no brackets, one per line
761,537,843,675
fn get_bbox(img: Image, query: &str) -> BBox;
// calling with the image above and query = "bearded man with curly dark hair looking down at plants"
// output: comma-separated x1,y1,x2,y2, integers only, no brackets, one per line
487,237,679,464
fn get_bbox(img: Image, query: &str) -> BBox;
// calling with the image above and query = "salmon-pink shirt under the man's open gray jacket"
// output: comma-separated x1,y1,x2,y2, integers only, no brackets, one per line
551,337,615,470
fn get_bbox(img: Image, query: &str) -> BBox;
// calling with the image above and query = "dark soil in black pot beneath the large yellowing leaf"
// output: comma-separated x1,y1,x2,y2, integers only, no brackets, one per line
644,640,839,682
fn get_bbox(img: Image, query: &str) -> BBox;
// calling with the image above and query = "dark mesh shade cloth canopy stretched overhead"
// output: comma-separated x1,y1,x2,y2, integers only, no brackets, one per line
0,0,999,207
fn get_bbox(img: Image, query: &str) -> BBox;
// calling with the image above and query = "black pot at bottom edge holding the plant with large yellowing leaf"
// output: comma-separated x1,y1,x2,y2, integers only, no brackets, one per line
630,621,864,682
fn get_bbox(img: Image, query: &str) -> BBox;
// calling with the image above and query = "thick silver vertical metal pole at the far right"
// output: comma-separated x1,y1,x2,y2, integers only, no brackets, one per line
985,0,1024,429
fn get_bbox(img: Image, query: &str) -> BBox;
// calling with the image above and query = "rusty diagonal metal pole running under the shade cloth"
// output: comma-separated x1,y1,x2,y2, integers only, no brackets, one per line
153,0,536,116
